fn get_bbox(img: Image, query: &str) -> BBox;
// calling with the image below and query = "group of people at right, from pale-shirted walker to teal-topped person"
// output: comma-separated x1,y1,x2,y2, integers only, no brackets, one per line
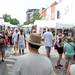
44,29,75,75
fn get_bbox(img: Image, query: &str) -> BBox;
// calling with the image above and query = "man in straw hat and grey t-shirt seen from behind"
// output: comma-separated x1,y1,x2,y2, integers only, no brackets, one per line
12,33,54,75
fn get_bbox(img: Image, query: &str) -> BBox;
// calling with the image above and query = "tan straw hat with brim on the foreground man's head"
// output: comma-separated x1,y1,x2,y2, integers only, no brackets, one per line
26,33,42,46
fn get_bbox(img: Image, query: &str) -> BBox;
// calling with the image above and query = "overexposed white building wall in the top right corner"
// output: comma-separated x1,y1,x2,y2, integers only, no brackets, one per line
56,0,75,20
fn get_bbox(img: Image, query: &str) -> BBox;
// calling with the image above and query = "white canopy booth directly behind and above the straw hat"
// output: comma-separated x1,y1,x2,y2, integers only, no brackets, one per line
34,20,56,33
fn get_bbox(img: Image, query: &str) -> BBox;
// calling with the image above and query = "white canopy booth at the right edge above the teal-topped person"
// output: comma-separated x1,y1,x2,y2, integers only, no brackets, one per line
56,19,75,36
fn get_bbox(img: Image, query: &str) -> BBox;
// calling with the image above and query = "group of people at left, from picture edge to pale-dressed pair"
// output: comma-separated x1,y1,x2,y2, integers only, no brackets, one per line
0,28,26,61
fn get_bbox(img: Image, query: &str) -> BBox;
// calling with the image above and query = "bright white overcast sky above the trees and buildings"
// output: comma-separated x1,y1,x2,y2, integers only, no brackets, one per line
0,0,51,23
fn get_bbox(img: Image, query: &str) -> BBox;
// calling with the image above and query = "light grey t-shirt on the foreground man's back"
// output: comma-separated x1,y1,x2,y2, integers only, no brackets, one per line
12,53,54,75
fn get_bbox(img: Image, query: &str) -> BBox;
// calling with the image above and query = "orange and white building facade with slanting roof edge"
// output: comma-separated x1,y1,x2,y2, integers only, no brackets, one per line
40,0,61,20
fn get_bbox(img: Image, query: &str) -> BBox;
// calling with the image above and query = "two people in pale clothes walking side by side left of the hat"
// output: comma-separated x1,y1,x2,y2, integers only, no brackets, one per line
12,29,26,54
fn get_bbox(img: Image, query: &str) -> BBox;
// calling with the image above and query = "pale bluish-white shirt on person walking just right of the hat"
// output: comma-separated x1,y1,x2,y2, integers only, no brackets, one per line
43,32,53,47
